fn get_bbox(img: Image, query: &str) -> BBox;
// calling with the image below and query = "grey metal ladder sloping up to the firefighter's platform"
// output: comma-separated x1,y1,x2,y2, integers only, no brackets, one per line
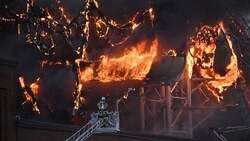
66,119,104,141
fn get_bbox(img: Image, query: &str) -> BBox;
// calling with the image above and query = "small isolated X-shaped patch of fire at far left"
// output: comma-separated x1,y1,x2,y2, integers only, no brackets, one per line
19,77,40,114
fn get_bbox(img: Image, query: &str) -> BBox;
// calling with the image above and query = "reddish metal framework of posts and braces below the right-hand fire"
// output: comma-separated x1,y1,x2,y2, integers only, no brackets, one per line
139,70,226,138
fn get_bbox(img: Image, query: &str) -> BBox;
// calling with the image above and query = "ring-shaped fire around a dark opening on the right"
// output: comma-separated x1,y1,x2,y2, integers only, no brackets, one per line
186,22,239,101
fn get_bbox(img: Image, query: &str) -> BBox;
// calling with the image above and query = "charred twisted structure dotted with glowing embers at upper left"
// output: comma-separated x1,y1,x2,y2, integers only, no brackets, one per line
0,0,154,59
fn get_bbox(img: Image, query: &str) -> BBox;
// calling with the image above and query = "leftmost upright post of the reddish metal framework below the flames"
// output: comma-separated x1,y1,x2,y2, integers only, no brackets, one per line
139,86,145,131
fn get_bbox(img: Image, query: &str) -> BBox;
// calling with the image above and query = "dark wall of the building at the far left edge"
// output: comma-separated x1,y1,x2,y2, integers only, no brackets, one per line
0,59,16,141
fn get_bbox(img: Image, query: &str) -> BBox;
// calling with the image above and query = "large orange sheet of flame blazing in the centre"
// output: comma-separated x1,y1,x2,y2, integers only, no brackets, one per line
77,39,158,83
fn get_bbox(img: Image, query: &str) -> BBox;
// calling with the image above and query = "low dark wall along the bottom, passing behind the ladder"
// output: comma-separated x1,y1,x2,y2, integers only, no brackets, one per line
16,119,199,141
